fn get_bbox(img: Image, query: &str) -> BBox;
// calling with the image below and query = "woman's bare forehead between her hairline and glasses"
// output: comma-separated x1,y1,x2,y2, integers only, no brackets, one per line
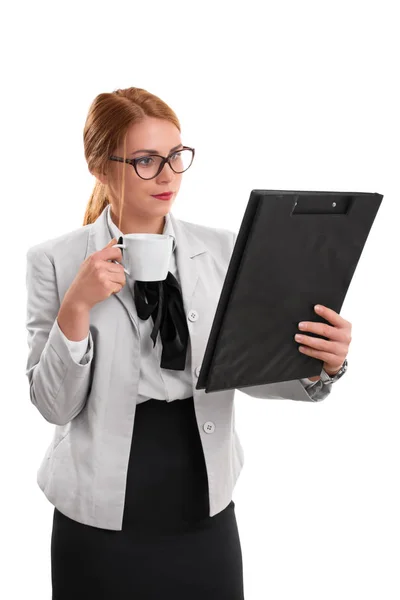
126,117,181,153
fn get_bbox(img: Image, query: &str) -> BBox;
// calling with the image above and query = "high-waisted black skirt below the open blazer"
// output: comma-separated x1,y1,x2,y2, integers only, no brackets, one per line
51,396,244,600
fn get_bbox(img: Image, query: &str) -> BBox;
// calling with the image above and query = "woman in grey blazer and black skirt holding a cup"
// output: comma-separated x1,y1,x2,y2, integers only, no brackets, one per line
27,88,350,600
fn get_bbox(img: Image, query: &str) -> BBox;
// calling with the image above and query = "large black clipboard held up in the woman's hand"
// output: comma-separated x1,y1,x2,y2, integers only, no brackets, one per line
196,190,383,392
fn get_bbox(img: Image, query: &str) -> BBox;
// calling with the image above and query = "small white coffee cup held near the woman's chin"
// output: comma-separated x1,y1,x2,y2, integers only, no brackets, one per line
112,233,174,281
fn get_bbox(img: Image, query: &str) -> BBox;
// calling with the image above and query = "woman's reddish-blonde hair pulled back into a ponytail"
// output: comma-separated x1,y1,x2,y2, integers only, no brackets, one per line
83,87,181,228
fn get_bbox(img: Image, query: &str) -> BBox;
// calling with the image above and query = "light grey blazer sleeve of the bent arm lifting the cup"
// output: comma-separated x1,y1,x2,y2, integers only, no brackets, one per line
26,247,94,425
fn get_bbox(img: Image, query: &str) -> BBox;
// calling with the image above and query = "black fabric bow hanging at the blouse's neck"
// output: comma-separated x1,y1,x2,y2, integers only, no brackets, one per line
118,238,189,371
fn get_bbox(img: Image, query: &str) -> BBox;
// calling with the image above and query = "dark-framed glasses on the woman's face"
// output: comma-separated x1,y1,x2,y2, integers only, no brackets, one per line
109,146,194,179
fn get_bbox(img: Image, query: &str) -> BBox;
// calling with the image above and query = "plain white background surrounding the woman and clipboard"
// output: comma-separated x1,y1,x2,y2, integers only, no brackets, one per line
0,0,400,600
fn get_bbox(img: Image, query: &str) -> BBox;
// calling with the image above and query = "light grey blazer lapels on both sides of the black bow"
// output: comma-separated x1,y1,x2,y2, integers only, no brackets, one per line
85,209,207,335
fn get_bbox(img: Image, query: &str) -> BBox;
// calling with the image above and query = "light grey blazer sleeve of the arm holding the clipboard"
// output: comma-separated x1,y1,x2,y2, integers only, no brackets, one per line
231,231,332,402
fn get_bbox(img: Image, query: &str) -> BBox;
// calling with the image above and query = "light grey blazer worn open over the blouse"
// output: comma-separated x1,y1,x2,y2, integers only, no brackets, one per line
26,206,331,530
